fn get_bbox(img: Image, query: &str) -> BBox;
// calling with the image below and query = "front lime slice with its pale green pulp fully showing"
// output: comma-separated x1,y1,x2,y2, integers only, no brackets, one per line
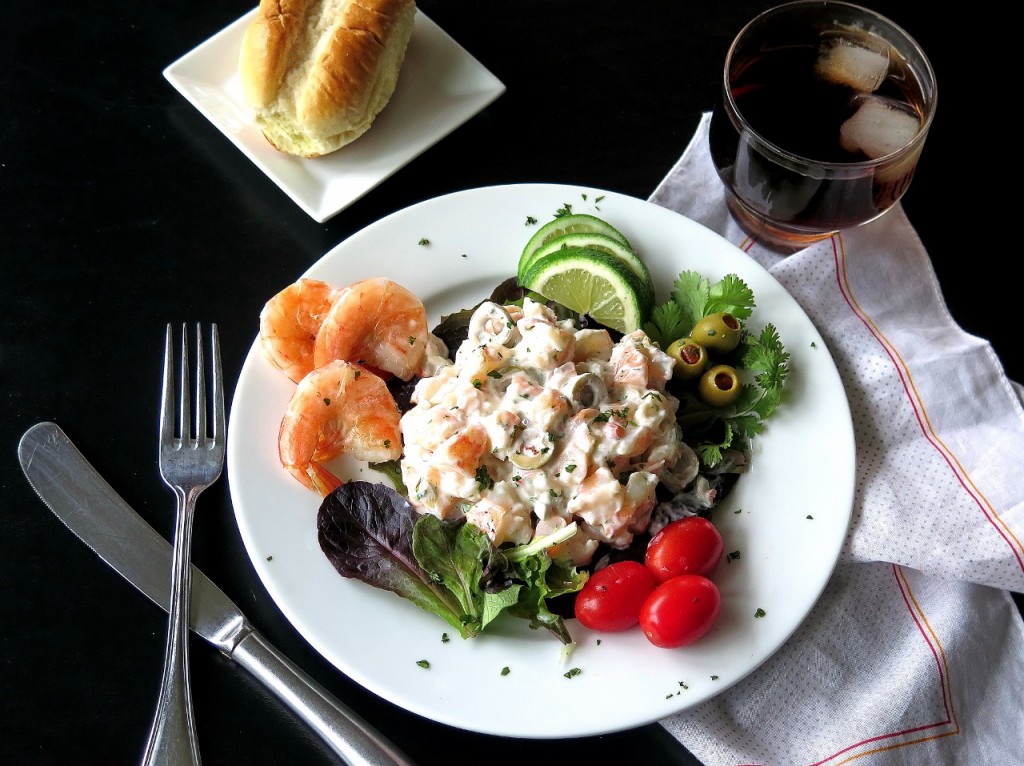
520,247,648,333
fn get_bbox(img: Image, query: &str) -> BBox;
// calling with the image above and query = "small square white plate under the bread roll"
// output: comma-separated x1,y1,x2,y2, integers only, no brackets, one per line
164,8,505,223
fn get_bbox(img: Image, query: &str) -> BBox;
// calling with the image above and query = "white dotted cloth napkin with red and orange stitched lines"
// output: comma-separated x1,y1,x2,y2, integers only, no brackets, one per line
650,114,1024,766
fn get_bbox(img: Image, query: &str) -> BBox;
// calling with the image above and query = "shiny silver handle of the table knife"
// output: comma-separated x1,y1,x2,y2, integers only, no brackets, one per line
231,630,414,766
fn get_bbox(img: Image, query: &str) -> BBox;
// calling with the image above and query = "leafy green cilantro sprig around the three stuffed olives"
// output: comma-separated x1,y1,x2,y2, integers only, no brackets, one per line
644,271,790,468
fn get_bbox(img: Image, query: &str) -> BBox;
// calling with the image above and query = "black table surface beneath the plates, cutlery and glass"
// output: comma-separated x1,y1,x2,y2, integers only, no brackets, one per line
6,0,1024,766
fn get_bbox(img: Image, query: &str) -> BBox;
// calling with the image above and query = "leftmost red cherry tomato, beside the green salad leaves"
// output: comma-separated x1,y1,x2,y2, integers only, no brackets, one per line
575,561,655,633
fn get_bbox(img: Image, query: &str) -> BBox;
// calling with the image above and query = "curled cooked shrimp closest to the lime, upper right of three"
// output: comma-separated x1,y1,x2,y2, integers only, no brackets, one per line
313,278,431,380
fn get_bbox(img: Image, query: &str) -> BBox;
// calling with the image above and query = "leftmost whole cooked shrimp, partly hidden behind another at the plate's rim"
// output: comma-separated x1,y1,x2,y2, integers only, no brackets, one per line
259,278,338,383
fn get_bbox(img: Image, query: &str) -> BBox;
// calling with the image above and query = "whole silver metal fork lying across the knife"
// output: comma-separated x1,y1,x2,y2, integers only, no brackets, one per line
142,325,226,766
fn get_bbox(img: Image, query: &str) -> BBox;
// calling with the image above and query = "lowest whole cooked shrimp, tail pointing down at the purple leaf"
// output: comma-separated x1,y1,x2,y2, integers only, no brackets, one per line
278,359,401,496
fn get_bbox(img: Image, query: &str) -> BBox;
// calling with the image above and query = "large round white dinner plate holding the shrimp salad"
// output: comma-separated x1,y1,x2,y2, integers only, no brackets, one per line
227,184,854,738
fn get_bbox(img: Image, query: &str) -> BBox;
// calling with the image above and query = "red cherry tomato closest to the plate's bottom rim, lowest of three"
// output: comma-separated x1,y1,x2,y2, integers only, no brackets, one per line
640,575,722,649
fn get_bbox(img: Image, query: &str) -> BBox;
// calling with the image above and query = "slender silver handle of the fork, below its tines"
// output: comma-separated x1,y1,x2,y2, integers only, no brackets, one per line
142,488,201,766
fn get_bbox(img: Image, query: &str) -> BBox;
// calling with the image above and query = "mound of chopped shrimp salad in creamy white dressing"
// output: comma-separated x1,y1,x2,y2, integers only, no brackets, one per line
401,298,695,564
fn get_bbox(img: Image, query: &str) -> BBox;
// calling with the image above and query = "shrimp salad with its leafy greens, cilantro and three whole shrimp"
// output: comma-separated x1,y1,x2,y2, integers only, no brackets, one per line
260,272,787,644
